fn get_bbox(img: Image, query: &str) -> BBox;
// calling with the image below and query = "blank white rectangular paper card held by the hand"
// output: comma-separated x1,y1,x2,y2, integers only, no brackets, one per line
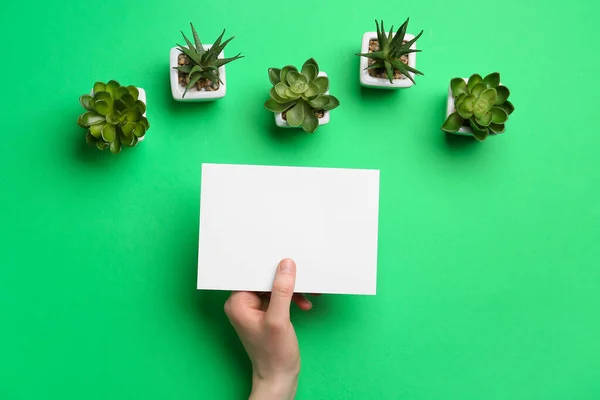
198,164,379,294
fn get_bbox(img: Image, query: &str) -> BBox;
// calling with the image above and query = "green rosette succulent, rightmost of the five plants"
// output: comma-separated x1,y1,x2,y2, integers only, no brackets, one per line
442,72,515,141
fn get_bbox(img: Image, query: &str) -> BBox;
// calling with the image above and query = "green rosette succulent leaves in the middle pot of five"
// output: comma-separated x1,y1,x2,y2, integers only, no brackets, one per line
265,58,340,133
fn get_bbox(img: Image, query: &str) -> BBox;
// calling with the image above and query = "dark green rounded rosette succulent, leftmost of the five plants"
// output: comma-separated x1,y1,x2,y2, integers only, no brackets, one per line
77,80,150,153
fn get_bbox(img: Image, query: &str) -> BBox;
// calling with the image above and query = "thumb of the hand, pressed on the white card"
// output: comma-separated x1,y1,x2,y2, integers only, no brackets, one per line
267,258,296,324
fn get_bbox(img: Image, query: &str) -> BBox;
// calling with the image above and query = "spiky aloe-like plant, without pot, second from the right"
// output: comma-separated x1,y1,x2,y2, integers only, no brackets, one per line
357,18,423,83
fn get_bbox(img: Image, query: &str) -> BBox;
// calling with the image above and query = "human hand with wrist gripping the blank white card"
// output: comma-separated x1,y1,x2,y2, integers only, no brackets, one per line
225,258,312,400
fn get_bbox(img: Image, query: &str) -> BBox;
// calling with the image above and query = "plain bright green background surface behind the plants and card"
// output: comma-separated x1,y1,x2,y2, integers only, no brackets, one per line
0,0,600,400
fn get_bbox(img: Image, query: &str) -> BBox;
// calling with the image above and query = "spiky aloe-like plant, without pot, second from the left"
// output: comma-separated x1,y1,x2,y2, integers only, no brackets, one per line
173,22,244,97
